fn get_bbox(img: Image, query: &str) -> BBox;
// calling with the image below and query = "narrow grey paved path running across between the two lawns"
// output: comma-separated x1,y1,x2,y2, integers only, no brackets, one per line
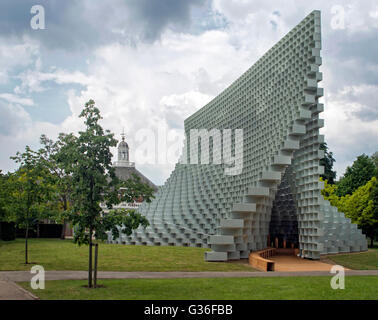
0,270,378,282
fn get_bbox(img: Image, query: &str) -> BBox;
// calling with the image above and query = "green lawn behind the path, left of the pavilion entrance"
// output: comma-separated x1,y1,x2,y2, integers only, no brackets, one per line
0,239,256,271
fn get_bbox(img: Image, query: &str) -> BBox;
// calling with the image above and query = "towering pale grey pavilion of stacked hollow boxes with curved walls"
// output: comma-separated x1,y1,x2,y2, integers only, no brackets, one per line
109,11,367,261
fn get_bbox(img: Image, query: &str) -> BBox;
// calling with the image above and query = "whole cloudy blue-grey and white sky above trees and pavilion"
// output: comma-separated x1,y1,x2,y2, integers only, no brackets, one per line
0,0,378,185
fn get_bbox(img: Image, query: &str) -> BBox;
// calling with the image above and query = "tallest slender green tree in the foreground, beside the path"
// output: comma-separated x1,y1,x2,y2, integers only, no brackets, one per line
63,100,152,288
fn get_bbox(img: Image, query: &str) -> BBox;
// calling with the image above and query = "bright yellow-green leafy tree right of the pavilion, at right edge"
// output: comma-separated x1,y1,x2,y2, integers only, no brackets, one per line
322,177,378,246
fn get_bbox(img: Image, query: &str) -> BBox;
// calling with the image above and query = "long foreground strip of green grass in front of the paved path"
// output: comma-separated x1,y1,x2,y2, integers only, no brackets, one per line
21,276,378,300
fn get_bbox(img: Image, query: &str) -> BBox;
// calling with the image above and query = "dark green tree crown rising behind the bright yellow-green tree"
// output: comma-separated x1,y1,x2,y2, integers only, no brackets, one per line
336,154,376,197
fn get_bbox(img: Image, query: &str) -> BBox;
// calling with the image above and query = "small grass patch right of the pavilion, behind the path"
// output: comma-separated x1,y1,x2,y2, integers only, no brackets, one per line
327,248,378,270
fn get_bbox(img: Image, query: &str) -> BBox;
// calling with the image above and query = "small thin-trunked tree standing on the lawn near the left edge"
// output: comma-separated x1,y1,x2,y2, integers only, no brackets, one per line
5,146,54,264
